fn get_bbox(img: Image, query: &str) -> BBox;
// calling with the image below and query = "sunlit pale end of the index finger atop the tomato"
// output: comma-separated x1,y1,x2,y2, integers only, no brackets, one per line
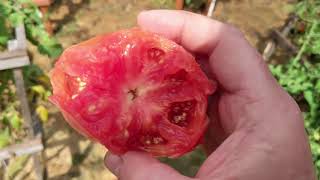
138,10,224,54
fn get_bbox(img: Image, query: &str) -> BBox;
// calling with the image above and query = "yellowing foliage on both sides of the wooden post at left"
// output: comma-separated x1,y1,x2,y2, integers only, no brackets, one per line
0,65,51,148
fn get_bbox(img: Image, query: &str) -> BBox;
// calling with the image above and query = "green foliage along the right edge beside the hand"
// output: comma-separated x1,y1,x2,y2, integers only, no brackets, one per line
270,0,320,178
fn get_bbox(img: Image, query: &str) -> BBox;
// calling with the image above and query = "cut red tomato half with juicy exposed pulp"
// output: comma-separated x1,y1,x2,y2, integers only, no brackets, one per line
50,28,215,157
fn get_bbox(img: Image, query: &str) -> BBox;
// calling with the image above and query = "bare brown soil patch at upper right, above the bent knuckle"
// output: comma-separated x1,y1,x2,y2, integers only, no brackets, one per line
214,0,291,51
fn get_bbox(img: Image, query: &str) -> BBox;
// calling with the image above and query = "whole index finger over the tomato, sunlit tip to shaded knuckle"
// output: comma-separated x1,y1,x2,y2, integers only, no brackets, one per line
138,10,276,95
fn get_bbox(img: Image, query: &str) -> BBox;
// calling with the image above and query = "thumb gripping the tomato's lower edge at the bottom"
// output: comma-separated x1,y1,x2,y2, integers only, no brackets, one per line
105,152,191,180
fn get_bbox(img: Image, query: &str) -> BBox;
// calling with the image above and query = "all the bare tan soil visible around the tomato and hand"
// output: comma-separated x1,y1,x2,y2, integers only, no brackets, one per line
15,0,288,180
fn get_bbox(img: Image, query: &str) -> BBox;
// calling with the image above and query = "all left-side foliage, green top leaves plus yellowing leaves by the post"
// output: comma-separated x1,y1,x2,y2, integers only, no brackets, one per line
0,0,62,148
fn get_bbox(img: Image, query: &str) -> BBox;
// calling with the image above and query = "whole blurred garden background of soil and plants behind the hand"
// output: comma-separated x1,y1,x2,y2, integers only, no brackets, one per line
0,0,320,180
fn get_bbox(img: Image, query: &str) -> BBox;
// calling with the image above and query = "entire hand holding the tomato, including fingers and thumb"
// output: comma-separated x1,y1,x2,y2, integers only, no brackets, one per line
105,10,316,180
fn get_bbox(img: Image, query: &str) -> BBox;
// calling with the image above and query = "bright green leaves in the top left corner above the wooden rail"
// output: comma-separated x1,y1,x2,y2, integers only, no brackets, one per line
0,0,62,58
